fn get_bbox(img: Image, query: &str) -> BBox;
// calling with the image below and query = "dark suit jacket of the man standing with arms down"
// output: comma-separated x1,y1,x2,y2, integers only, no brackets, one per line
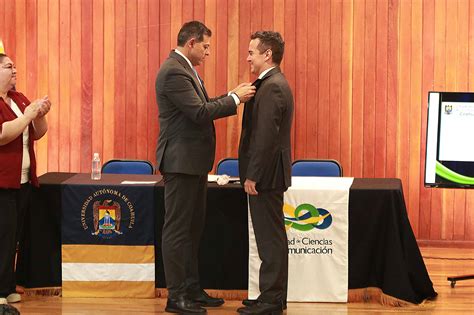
239,67,293,190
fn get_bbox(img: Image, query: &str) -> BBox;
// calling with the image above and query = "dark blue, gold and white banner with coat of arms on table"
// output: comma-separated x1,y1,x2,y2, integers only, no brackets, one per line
61,174,155,298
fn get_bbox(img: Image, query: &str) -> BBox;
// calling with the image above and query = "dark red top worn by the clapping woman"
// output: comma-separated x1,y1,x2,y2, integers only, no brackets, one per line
0,91,38,188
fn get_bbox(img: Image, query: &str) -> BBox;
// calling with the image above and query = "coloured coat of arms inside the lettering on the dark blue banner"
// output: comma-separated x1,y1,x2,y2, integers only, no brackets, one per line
92,200,122,236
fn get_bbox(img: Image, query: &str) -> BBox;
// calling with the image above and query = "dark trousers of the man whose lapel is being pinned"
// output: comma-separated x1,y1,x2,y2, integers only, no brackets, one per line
249,191,288,304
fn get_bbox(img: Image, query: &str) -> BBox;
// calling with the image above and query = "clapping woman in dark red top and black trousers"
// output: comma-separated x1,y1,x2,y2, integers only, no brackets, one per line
0,54,51,304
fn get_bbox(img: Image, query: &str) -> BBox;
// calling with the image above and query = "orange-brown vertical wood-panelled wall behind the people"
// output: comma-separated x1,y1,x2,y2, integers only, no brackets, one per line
0,0,474,244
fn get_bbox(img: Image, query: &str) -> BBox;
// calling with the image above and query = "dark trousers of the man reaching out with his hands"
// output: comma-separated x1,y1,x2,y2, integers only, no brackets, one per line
162,173,207,299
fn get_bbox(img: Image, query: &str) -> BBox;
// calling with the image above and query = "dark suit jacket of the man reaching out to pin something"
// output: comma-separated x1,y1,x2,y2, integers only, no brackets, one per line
155,51,237,175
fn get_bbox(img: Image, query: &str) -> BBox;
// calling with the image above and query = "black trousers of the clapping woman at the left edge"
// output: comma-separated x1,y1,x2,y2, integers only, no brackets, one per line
0,184,31,297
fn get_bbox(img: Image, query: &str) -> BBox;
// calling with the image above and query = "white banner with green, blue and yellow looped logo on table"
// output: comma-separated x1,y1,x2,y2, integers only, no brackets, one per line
248,177,353,302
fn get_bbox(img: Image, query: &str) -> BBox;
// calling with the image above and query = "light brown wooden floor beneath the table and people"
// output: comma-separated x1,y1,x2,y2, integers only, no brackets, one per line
14,248,474,315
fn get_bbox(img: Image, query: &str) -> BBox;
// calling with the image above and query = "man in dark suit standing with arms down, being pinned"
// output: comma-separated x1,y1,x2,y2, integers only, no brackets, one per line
237,31,293,314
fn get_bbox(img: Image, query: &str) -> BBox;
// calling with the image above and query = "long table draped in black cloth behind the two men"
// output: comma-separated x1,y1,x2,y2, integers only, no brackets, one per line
17,173,437,303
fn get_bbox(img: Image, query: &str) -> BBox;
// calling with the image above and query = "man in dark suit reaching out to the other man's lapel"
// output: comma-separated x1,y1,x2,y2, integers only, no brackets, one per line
156,21,255,313
